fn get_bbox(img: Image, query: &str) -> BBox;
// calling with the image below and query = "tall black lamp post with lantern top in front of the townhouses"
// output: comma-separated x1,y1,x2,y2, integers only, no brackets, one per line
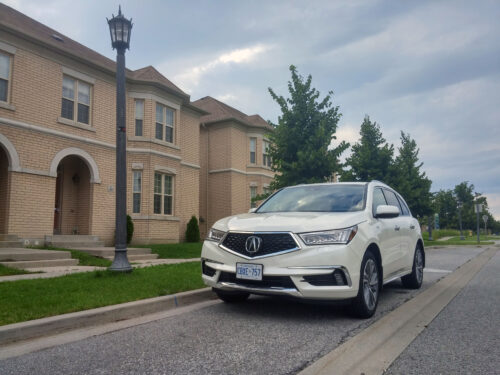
106,7,132,272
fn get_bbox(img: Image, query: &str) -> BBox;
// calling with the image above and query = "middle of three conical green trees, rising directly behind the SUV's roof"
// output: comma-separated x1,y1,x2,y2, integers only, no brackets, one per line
341,116,394,184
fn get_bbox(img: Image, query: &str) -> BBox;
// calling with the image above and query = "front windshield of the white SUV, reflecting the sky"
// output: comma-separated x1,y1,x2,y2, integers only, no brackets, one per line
256,184,365,213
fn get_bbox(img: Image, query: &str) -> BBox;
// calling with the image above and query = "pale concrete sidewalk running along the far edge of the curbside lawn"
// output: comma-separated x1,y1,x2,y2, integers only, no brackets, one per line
0,258,200,282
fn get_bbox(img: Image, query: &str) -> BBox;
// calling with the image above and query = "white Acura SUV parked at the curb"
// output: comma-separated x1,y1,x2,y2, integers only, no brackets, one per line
201,181,425,318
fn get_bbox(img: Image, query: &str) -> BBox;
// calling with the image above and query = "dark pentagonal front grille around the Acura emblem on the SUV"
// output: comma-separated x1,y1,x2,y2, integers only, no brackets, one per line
221,232,299,259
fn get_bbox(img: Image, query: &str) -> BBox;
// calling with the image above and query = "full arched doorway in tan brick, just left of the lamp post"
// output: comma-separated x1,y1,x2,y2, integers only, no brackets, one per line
54,155,92,234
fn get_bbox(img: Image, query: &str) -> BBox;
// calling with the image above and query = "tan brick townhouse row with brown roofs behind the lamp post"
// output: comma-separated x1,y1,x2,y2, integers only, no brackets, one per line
0,4,273,244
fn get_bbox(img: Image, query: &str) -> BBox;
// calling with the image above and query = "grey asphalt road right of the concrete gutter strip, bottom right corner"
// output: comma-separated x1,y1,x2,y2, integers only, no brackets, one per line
387,248,500,375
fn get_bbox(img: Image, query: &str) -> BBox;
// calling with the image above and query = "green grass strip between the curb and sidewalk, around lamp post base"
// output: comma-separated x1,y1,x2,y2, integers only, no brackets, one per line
0,262,204,325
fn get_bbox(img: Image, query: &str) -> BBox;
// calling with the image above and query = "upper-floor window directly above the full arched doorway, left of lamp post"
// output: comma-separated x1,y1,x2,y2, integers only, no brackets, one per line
61,76,90,125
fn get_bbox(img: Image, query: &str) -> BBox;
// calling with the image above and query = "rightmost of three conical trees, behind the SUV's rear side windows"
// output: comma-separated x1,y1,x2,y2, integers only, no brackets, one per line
392,131,432,217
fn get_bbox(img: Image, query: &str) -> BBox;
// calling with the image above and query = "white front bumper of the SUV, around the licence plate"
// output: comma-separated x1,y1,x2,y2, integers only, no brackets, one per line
201,241,362,300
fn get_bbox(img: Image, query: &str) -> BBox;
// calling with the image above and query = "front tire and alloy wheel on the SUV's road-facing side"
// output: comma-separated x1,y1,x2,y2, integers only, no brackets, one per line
351,251,382,319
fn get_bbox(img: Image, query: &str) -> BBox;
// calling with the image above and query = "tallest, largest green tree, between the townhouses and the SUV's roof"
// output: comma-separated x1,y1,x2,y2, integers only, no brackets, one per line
268,65,349,190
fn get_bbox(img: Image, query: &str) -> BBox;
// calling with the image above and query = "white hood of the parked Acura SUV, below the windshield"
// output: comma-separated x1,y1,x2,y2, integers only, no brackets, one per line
214,211,366,233
